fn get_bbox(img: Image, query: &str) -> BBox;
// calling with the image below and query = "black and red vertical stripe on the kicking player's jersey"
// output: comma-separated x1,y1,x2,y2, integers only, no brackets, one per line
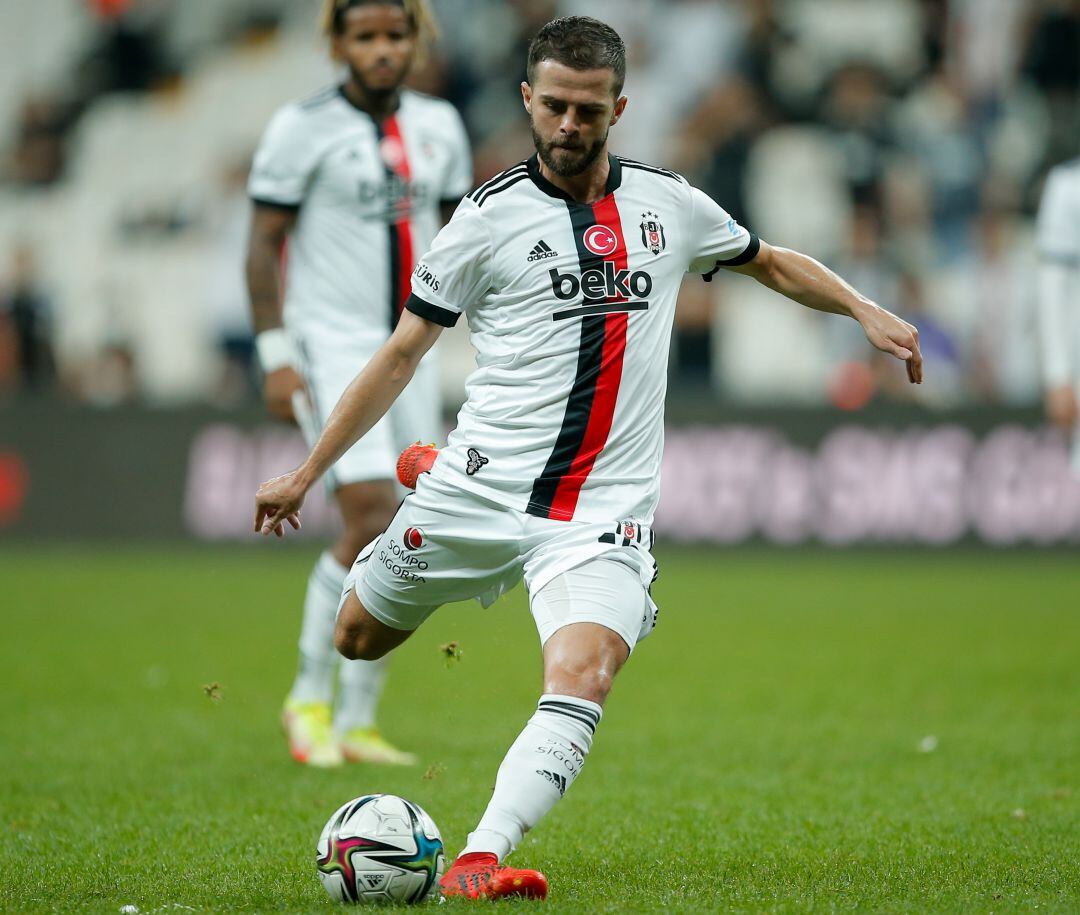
526,193,629,521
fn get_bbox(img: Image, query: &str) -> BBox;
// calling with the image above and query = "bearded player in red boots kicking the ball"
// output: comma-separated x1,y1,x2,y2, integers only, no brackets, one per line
255,16,922,898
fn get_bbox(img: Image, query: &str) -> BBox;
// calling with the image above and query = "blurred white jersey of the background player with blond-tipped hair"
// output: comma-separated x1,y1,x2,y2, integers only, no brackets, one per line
254,86,472,351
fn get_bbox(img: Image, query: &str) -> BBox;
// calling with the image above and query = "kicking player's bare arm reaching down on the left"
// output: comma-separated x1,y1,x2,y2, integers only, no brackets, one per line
255,311,443,537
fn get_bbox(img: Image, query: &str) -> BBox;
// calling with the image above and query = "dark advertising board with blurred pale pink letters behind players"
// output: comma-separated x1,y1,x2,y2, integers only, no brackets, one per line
0,405,1080,547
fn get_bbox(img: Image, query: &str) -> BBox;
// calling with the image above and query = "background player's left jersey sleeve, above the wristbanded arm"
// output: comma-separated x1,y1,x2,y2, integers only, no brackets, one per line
247,108,318,207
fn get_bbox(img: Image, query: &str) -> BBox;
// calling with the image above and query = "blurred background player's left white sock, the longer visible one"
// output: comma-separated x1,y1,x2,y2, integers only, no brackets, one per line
289,552,349,702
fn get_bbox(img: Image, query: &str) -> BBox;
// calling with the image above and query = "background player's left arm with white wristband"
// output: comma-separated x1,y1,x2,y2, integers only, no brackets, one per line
244,203,303,422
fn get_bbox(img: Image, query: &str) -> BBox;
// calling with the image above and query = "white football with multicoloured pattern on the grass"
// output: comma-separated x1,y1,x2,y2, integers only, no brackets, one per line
315,794,446,903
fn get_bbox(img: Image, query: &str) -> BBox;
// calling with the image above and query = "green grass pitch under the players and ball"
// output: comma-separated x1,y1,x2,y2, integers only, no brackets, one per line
0,543,1080,913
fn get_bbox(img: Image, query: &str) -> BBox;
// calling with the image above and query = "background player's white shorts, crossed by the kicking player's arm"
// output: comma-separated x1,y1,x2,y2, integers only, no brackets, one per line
294,335,443,490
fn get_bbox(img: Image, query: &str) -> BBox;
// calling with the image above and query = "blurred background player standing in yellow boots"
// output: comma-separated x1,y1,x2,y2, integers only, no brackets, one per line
247,0,472,766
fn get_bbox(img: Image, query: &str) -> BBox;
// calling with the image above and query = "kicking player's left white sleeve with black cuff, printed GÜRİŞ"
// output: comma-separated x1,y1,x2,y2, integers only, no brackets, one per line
405,198,491,327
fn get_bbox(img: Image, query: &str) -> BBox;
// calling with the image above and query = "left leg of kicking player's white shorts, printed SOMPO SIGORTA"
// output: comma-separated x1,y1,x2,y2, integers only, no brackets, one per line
346,474,521,631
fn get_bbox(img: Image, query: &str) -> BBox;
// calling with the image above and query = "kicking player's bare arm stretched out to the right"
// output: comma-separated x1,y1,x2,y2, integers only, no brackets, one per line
728,242,922,385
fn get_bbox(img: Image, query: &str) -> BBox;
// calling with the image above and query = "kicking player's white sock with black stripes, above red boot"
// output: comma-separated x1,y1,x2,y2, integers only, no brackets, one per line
461,695,603,861
